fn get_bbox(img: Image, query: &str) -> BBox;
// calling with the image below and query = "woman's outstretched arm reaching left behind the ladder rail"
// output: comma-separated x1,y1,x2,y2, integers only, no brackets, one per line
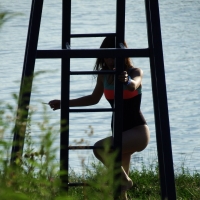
49,75,104,110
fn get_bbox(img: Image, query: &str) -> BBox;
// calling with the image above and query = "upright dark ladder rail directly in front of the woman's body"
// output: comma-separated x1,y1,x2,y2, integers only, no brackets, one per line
113,0,125,198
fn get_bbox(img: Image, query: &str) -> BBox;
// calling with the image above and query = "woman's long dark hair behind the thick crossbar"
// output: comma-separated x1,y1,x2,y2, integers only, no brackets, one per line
94,36,133,70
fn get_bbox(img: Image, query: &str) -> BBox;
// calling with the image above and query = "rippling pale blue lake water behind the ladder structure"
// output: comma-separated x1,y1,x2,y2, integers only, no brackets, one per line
0,0,200,171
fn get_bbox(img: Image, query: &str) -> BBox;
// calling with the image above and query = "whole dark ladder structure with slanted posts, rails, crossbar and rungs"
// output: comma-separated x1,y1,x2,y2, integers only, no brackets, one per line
11,0,176,200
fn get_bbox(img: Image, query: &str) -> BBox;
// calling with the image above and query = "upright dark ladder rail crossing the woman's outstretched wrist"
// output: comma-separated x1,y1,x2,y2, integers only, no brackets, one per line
60,0,71,190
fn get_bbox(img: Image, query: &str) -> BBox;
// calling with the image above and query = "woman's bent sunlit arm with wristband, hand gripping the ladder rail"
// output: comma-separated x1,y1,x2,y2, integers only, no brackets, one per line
119,68,143,91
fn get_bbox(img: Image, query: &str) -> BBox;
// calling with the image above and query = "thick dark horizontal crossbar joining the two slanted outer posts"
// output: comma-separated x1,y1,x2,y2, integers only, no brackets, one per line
36,48,150,59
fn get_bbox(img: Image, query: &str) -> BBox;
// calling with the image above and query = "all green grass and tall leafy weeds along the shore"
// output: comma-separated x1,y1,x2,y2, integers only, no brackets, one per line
0,95,200,200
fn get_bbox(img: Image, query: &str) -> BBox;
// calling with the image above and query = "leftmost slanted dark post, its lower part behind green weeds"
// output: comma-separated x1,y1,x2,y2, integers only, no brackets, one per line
11,0,43,164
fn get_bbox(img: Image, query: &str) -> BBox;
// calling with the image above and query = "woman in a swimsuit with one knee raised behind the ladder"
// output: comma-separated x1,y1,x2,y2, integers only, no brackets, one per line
49,37,150,199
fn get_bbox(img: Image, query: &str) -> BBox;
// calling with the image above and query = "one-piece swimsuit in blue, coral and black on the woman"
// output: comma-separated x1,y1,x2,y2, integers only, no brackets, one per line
104,75,146,131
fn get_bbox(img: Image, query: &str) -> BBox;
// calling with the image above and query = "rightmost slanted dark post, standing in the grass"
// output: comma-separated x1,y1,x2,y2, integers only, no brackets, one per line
145,0,176,200
